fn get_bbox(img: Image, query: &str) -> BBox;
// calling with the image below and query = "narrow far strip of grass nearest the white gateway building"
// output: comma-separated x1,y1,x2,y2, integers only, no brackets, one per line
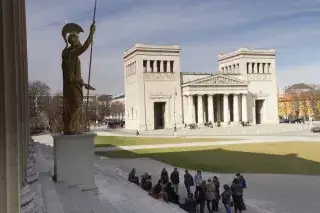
95,136,237,147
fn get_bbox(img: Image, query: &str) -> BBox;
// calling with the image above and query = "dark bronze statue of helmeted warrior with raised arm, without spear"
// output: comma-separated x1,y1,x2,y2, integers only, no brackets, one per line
61,22,96,135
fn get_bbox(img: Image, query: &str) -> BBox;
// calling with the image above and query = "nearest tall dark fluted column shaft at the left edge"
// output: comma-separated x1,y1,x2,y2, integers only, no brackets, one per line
0,0,25,213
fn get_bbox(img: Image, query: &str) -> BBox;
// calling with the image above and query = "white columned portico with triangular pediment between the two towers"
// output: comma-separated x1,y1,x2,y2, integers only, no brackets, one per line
182,73,248,126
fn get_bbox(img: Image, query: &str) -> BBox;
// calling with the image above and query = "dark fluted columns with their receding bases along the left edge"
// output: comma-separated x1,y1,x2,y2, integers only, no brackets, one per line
0,0,39,213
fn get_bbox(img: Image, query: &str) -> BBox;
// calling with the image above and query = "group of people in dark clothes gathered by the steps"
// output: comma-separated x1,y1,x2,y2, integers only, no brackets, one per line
128,168,247,213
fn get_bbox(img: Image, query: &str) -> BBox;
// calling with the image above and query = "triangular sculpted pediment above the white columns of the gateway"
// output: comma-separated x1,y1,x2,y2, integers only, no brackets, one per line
187,74,248,85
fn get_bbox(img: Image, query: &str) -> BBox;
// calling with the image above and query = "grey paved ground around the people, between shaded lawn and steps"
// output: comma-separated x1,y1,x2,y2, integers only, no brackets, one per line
96,158,320,213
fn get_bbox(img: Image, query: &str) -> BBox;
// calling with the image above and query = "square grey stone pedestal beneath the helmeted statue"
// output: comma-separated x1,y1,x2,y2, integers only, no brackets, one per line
52,133,97,190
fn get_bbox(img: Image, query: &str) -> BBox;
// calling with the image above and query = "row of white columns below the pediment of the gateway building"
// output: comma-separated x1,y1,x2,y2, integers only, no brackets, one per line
183,94,248,125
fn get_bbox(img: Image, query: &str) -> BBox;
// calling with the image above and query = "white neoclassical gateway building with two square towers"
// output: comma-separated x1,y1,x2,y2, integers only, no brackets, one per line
123,44,278,130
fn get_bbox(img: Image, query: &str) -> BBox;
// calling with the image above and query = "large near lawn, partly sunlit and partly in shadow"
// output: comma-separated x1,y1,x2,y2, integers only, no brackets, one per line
96,142,320,175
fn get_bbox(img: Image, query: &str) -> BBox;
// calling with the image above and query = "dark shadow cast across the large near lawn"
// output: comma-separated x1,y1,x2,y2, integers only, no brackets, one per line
96,149,320,175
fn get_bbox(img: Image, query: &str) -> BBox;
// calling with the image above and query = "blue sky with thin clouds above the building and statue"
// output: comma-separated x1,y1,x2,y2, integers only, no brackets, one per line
26,0,320,95
